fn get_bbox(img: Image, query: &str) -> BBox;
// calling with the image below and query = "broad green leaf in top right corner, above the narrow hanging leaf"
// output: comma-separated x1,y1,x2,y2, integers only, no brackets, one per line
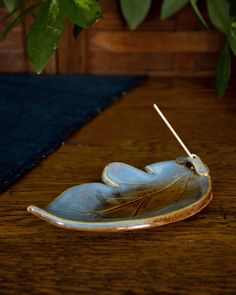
207,0,231,34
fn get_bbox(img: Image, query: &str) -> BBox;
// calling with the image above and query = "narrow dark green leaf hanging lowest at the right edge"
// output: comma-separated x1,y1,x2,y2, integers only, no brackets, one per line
216,39,231,97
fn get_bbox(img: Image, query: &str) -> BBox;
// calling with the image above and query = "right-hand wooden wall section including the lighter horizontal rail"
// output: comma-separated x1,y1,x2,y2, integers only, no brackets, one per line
85,0,223,76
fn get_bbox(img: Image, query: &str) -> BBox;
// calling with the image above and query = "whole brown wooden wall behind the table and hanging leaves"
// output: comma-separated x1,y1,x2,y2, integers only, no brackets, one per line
0,0,235,76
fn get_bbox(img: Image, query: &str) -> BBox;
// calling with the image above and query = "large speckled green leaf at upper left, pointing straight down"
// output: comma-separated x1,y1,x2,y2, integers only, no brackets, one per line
27,0,65,73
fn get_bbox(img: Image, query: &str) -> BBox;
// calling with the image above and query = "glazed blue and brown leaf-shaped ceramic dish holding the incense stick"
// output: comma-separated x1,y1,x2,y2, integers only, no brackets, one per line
28,155,212,231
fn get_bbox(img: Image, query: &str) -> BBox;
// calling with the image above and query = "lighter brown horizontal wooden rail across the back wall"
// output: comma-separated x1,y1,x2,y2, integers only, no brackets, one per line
88,31,223,53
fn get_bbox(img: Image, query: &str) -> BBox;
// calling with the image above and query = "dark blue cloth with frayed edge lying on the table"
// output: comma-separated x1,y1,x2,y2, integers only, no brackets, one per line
0,74,144,193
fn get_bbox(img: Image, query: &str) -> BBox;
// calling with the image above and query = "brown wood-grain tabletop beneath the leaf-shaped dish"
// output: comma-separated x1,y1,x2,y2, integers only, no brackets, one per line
0,78,236,294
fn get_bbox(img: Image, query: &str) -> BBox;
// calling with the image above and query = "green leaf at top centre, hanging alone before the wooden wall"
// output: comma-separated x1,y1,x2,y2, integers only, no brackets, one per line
120,0,151,30
